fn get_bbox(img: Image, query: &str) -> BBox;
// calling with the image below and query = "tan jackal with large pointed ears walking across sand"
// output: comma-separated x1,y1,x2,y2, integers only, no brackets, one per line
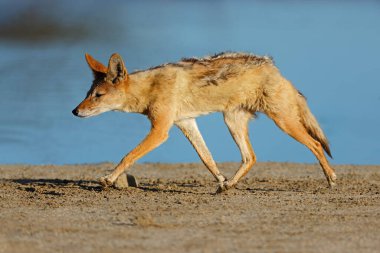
73,53,336,192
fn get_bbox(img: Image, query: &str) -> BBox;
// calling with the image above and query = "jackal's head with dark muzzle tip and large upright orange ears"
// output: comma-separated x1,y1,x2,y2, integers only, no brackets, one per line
73,54,128,117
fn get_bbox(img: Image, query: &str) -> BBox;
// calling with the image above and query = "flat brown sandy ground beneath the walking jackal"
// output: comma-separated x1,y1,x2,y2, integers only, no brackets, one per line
0,163,380,253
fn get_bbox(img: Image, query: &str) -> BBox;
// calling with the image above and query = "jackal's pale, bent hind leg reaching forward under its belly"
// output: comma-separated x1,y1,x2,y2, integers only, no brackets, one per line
217,110,256,192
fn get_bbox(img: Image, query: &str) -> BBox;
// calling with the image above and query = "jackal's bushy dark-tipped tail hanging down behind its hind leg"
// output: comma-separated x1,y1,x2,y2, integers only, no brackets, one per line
298,94,332,158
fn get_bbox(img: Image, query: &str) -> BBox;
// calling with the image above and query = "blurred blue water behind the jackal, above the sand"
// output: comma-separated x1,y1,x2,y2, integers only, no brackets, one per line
0,0,380,164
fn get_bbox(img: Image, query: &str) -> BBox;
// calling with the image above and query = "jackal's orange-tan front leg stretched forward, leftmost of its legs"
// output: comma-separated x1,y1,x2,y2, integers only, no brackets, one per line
100,119,172,187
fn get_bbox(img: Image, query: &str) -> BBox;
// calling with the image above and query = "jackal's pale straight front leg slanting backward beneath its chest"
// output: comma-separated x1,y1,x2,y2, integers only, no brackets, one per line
175,119,226,186
